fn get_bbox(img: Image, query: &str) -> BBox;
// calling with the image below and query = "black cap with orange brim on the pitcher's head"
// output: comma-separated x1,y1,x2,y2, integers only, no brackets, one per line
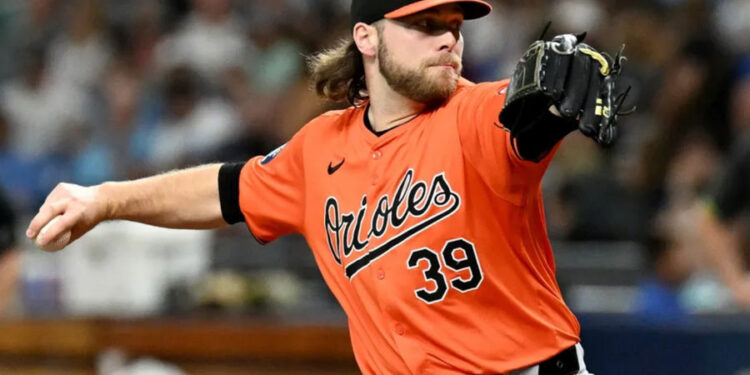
351,0,492,27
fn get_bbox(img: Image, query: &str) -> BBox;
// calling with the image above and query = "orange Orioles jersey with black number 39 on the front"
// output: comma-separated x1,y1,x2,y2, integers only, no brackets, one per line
239,81,580,375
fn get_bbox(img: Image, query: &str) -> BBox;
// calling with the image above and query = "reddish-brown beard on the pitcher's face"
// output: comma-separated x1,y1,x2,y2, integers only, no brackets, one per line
378,41,461,107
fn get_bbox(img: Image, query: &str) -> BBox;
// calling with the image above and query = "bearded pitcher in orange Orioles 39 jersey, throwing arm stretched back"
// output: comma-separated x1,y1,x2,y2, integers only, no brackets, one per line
26,0,636,375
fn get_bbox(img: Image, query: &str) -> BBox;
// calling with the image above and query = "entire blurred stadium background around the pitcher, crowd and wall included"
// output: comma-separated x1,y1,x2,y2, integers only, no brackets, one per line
0,0,750,375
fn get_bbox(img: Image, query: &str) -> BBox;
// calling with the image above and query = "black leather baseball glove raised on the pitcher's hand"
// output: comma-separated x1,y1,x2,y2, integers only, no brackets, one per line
500,33,631,155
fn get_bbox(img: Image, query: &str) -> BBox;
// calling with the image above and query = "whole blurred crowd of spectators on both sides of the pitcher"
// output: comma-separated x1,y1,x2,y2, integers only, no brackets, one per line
0,0,750,317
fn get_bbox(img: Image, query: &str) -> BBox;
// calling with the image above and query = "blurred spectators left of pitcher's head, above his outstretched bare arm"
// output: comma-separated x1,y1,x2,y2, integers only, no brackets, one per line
0,0,352,210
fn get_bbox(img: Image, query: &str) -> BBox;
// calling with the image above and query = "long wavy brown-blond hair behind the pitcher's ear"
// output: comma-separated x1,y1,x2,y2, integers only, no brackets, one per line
307,39,368,106
